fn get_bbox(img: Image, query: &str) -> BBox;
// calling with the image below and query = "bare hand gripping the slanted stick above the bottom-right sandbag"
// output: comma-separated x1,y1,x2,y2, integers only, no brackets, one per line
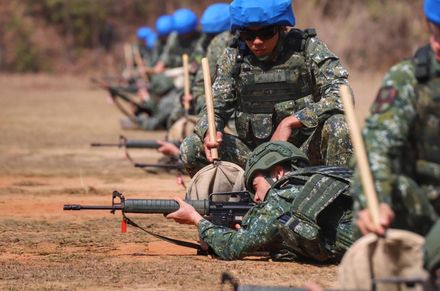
356,203,394,236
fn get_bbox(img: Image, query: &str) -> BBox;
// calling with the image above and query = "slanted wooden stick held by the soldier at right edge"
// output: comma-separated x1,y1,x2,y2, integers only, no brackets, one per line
340,85,380,227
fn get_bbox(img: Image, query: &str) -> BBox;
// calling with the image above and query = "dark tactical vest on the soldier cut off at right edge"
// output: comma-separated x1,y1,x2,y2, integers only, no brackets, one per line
413,45,440,186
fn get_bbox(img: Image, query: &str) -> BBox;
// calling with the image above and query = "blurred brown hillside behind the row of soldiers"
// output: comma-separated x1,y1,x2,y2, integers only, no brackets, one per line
0,0,427,75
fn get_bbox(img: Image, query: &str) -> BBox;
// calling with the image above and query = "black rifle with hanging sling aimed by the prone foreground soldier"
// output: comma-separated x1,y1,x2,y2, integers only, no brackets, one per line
63,191,255,253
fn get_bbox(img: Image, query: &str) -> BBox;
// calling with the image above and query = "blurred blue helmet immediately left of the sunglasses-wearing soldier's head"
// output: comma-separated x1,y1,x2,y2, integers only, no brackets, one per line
200,3,231,33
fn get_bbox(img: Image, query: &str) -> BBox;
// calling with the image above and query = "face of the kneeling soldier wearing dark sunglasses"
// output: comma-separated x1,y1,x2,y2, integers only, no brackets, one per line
239,26,280,57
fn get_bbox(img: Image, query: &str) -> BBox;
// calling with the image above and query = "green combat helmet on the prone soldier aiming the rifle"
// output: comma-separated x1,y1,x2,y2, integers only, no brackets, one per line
244,141,310,193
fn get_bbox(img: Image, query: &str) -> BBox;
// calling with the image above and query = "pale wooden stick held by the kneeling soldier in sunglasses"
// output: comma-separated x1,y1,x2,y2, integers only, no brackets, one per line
202,58,218,160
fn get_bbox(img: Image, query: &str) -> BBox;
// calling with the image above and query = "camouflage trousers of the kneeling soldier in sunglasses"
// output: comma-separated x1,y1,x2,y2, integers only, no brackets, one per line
180,114,353,177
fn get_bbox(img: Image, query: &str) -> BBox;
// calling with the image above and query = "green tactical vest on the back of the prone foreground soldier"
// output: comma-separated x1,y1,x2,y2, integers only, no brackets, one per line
272,166,353,262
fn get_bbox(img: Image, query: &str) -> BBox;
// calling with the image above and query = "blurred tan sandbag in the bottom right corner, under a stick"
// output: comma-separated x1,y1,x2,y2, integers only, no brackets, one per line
338,229,427,291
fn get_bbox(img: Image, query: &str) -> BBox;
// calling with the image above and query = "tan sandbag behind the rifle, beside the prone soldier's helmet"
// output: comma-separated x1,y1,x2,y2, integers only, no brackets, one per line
186,161,245,201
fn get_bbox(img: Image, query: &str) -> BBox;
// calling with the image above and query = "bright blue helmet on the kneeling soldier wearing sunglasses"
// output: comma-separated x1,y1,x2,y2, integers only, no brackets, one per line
230,0,295,30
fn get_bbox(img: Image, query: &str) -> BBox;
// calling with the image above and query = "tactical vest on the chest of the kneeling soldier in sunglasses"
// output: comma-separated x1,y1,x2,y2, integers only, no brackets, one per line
234,29,316,147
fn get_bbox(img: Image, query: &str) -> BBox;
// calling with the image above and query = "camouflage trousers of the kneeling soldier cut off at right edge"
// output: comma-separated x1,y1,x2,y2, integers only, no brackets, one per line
353,175,440,238
